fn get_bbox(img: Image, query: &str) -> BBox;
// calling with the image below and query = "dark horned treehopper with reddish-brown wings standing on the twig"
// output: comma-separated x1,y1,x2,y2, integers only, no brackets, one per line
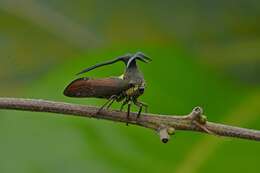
64,52,151,123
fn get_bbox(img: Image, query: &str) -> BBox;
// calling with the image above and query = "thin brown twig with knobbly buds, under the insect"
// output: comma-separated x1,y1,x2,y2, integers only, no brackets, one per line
0,98,260,143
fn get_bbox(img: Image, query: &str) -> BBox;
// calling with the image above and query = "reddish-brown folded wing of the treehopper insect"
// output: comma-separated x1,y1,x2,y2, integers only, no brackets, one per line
64,78,129,98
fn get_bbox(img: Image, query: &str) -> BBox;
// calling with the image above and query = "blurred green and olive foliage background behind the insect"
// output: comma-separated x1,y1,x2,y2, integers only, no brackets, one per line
0,0,260,173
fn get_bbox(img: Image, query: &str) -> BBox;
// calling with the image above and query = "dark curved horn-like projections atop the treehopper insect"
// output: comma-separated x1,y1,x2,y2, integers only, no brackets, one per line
77,52,151,75
